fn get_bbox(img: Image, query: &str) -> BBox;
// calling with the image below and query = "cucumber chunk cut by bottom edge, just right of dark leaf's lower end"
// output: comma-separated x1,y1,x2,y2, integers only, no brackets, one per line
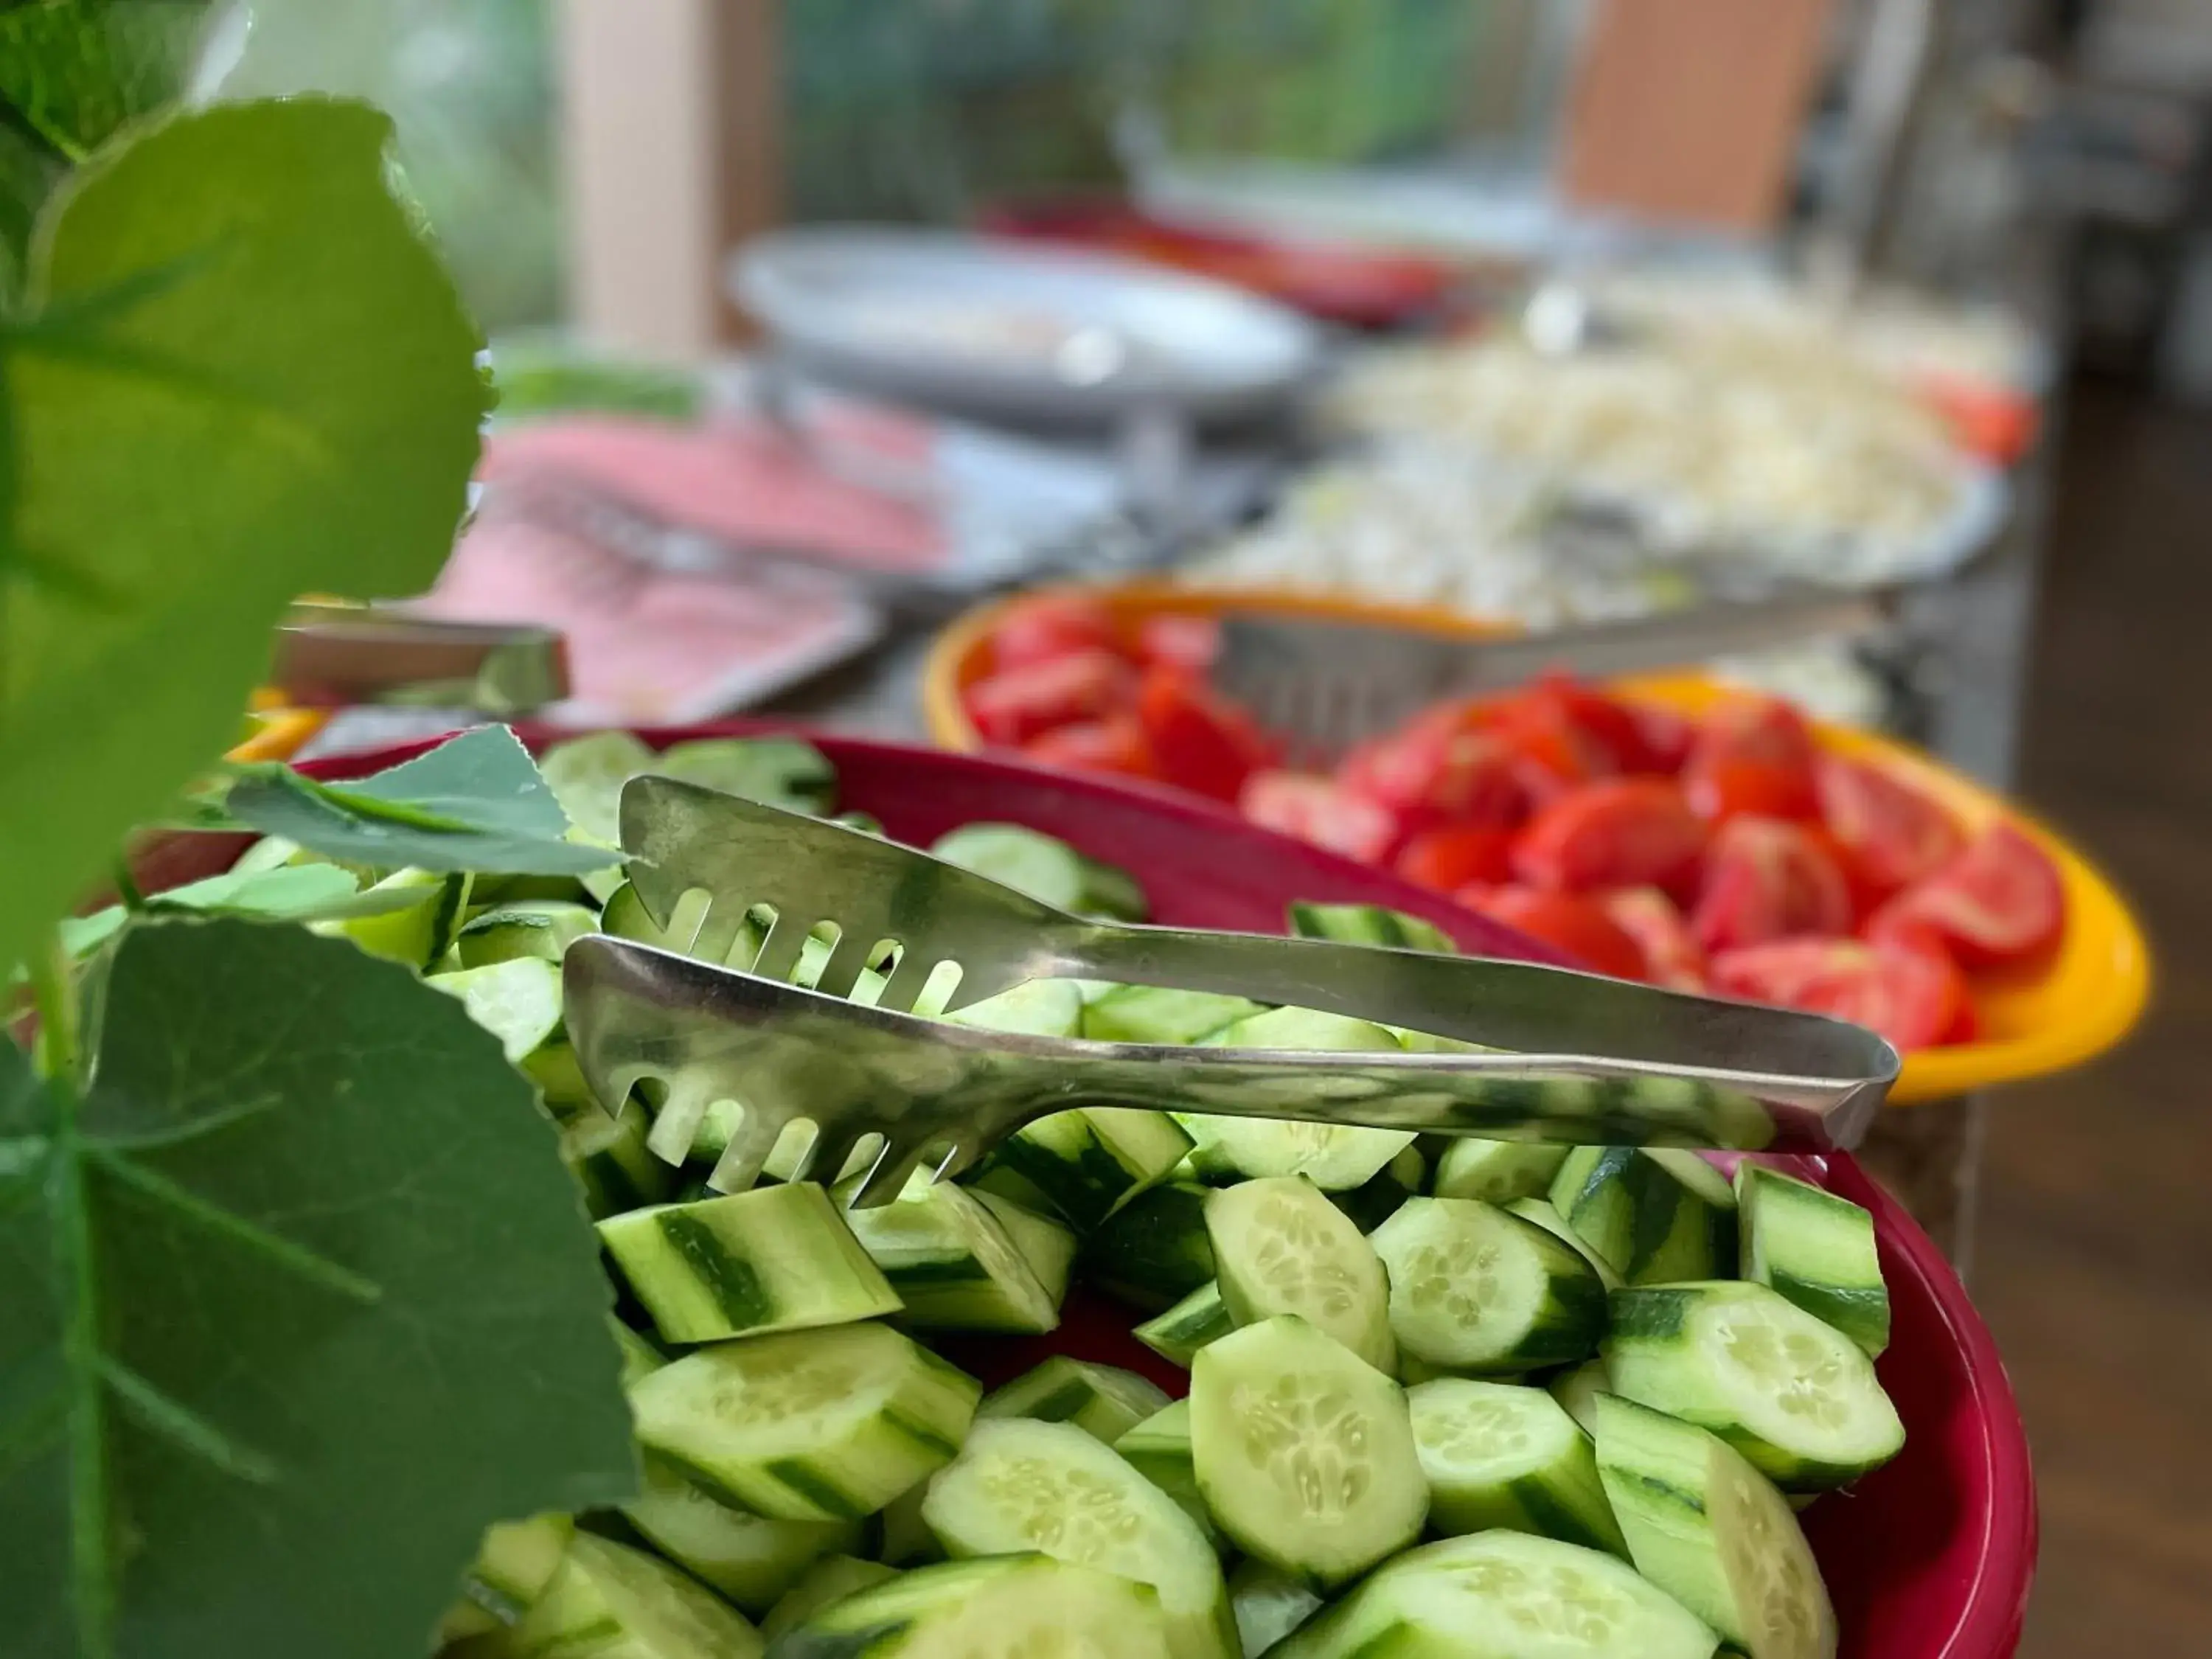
513,1533,765,1659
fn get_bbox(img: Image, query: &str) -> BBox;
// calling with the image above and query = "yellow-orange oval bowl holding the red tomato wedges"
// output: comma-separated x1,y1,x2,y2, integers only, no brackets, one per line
922,582,2152,1106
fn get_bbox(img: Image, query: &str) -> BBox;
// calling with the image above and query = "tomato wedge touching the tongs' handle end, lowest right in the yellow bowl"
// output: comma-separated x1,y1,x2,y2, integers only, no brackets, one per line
1712,938,1966,1048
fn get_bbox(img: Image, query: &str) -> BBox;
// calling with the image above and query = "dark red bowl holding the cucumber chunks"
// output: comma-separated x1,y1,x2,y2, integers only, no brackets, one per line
156,721,2035,1659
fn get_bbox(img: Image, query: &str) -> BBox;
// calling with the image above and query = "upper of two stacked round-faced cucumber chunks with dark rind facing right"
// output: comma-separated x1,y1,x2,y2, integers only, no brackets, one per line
1374,1199,1606,1376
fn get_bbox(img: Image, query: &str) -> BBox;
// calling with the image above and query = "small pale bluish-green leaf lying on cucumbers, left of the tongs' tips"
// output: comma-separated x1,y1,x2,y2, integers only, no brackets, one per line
223,726,622,876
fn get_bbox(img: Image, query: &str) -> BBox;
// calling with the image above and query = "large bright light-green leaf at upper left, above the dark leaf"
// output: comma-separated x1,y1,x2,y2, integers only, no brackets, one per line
0,100,484,987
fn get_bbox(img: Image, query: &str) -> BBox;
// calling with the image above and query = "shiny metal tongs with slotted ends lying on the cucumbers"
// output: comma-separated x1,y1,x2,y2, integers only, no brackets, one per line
562,776,1898,1206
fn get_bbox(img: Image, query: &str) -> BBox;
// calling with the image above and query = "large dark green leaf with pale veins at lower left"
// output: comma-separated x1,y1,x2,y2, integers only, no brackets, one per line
0,920,635,1659
